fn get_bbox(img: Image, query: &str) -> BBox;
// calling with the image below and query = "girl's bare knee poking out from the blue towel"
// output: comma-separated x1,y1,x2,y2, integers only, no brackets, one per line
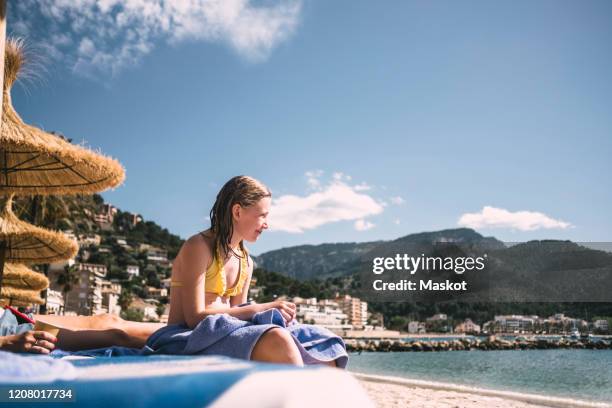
251,328,304,366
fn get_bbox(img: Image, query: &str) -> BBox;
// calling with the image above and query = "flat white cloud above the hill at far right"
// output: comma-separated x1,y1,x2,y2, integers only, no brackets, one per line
458,206,572,231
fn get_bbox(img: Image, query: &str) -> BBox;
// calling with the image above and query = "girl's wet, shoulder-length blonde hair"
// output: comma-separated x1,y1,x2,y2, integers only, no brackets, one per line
210,176,272,256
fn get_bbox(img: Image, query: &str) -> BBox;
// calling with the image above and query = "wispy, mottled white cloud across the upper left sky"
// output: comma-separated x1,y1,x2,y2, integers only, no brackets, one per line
8,0,302,76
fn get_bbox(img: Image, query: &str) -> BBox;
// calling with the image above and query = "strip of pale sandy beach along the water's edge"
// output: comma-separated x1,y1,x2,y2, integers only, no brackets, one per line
355,374,612,408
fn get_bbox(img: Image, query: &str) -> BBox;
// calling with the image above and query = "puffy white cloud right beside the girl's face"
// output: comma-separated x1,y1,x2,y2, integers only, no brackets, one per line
269,176,383,233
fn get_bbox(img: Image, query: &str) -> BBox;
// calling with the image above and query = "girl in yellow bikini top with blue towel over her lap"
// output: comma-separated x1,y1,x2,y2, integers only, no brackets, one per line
160,176,348,367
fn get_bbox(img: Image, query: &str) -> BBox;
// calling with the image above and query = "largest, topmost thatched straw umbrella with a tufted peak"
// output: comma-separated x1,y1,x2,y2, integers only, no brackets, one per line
0,39,125,195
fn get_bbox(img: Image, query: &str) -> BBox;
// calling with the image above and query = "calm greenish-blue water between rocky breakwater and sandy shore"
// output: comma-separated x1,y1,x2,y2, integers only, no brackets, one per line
348,350,612,402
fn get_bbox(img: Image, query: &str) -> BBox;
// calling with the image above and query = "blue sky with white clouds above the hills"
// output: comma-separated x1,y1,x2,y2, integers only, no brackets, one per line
7,0,612,254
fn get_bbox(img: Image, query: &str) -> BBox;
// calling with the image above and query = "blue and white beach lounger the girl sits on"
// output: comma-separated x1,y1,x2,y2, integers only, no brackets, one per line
0,352,373,408
